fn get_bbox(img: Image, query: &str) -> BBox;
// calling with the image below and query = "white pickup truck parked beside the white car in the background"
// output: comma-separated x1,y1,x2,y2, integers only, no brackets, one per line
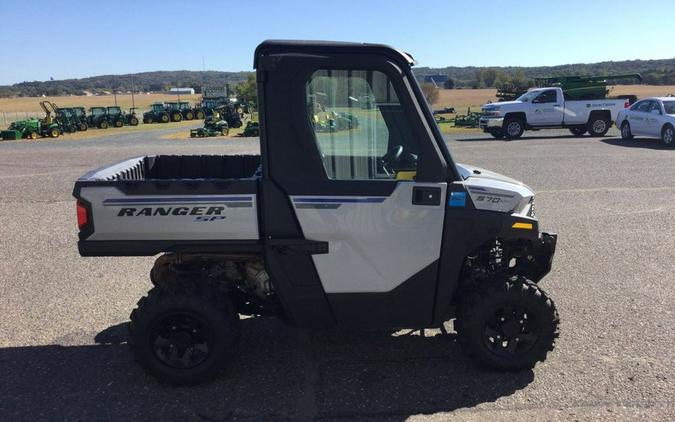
479,87,630,139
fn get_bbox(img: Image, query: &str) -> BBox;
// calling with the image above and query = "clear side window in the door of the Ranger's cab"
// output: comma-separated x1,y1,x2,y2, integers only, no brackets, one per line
306,70,418,180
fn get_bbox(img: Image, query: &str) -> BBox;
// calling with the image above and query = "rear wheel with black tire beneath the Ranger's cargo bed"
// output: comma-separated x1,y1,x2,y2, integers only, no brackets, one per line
128,280,239,384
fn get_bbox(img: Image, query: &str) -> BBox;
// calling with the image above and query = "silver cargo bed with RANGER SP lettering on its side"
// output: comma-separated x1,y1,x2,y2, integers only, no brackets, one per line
73,155,260,256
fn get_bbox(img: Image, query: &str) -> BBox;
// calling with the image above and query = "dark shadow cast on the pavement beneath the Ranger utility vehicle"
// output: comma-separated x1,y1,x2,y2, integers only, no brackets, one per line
0,318,533,421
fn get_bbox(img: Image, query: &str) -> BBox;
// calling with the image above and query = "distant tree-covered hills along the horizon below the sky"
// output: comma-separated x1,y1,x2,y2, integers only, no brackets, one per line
0,58,675,97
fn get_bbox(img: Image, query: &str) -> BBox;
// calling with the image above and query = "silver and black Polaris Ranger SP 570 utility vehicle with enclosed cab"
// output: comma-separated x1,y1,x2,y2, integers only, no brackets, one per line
73,41,558,384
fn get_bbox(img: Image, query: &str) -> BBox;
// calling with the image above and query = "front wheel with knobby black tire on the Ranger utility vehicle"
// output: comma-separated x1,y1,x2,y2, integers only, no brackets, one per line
455,277,559,370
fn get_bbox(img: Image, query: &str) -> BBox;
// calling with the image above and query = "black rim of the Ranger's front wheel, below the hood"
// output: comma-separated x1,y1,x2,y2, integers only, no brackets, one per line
483,306,539,357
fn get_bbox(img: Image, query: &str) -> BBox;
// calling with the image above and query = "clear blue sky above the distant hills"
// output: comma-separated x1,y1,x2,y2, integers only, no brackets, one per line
0,0,675,85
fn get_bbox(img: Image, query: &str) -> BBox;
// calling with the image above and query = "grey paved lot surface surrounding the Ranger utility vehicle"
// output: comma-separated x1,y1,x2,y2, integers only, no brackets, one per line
0,127,675,421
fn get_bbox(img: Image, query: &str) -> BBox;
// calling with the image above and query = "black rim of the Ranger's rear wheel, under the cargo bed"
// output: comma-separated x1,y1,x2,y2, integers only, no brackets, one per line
149,311,213,369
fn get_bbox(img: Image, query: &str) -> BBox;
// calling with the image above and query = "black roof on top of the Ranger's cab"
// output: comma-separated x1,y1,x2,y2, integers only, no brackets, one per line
253,40,415,69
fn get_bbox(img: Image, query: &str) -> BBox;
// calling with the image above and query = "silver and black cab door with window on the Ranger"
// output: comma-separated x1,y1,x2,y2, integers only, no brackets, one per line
263,48,448,326
